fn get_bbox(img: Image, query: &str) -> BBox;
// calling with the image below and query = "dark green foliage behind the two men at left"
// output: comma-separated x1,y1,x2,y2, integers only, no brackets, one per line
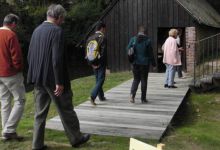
0,0,106,55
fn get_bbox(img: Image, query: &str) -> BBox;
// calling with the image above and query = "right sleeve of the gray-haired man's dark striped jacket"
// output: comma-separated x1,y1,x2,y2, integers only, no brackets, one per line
52,28,64,85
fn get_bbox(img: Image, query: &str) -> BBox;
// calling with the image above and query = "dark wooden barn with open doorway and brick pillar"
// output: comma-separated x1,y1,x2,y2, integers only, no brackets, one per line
87,0,220,72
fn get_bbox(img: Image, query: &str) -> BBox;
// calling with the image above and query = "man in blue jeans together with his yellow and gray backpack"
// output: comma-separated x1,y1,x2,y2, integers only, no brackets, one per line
86,22,107,106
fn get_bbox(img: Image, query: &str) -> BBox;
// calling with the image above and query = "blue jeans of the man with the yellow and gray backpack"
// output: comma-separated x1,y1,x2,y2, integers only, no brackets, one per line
91,66,106,99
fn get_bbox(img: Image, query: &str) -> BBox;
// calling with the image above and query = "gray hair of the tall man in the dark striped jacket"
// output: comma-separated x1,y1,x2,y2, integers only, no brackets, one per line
47,4,66,19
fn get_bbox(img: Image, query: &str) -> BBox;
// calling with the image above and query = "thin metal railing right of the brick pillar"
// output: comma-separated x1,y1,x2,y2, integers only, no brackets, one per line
194,33,220,86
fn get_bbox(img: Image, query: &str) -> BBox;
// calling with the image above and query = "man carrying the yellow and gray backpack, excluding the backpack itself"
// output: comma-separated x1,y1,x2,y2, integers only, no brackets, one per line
87,22,107,106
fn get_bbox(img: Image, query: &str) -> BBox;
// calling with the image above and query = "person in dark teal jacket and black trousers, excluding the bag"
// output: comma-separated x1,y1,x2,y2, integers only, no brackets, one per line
127,26,156,103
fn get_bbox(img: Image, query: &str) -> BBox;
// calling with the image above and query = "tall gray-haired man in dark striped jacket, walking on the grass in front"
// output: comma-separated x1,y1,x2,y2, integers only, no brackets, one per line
28,4,90,150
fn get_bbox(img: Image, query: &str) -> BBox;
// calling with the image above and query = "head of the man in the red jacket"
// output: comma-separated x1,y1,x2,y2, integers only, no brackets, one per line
3,14,19,29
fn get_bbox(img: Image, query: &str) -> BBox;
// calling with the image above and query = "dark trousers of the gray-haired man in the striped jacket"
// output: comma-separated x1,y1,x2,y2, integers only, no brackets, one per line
32,86,81,149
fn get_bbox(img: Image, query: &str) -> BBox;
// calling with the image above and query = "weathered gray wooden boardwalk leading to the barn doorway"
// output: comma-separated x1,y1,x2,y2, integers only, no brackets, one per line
46,73,189,140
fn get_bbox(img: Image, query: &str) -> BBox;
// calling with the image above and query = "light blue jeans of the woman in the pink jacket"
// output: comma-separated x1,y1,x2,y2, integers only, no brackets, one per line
165,64,176,86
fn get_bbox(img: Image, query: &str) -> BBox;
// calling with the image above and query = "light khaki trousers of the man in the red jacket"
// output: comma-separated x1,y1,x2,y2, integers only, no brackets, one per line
0,73,25,134
